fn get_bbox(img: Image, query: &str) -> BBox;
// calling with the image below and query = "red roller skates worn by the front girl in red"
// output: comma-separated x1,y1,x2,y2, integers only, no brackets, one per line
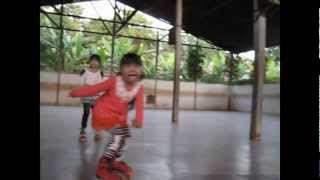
96,157,132,180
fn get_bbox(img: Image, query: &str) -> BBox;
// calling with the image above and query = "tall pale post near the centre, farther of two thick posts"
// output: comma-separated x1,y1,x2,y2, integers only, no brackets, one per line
172,0,182,123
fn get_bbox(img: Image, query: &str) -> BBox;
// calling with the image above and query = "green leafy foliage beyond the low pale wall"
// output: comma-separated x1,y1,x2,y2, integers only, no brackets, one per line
40,4,280,84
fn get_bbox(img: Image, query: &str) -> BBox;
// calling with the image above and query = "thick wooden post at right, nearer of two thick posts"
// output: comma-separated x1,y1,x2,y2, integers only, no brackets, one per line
250,0,266,140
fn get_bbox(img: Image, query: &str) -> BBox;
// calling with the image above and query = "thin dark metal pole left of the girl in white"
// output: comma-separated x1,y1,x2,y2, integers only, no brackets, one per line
56,4,63,105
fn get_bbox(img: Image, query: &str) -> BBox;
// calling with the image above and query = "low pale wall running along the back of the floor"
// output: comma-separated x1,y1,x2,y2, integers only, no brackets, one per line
40,72,280,114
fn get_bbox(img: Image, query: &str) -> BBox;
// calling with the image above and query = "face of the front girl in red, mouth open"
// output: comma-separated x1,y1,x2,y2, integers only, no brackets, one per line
121,64,142,84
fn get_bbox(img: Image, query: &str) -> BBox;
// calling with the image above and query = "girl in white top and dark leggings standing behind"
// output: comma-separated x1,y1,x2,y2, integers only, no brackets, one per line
79,55,103,142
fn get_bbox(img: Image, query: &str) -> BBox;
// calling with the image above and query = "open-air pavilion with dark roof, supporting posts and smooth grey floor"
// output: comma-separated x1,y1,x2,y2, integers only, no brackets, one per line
40,0,280,180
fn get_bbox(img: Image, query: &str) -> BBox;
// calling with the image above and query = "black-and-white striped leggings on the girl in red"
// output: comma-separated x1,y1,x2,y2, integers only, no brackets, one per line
104,126,131,159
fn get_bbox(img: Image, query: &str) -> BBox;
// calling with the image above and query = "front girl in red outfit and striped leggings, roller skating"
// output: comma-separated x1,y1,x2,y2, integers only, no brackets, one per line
70,53,144,179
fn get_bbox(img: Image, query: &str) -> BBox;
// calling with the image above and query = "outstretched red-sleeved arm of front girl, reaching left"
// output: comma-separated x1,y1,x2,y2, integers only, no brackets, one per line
70,77,115,97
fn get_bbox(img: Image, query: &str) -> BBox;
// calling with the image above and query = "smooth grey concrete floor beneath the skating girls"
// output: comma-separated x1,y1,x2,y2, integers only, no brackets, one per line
40,106,280,180
